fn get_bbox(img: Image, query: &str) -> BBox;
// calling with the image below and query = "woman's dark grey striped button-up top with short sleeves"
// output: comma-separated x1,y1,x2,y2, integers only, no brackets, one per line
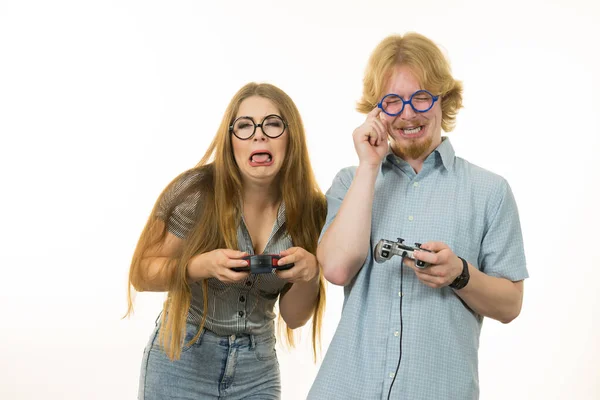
158,173,292,336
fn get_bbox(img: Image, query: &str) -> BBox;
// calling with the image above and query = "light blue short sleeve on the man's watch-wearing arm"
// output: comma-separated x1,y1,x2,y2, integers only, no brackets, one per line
478,180,529,282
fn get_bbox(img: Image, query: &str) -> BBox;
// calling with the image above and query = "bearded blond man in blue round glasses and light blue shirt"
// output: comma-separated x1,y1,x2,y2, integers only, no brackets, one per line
309,33,528,400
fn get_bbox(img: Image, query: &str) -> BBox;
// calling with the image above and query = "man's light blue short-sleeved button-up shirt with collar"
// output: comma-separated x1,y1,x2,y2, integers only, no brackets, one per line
308,138,528,400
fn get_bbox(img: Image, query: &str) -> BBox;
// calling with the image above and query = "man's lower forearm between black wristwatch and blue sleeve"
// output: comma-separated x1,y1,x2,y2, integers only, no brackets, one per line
456,264,523,324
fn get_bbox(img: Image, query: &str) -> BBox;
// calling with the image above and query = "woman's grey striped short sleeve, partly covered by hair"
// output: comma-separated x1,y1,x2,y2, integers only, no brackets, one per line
156,172,200,239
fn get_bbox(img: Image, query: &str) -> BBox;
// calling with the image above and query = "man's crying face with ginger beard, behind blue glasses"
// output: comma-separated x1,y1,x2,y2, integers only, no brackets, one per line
380,65,442,161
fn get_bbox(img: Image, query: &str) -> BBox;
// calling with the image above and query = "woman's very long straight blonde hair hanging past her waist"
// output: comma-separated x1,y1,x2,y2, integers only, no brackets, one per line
127,83,327,360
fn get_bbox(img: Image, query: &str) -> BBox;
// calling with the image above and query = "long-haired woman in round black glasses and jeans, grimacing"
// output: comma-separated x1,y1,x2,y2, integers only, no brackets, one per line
123,83,327,400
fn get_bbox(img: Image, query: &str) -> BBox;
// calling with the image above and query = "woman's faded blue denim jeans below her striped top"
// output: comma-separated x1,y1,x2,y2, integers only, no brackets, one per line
138,324,281,400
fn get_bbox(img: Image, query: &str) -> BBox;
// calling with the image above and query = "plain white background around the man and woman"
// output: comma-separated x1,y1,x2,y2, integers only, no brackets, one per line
0,0,600,400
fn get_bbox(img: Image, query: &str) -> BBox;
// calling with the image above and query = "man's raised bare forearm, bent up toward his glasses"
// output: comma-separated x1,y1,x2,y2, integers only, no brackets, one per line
317,166,380,285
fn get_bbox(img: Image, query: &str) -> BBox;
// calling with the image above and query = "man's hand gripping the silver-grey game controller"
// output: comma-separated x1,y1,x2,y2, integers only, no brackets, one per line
404,242,463,288
